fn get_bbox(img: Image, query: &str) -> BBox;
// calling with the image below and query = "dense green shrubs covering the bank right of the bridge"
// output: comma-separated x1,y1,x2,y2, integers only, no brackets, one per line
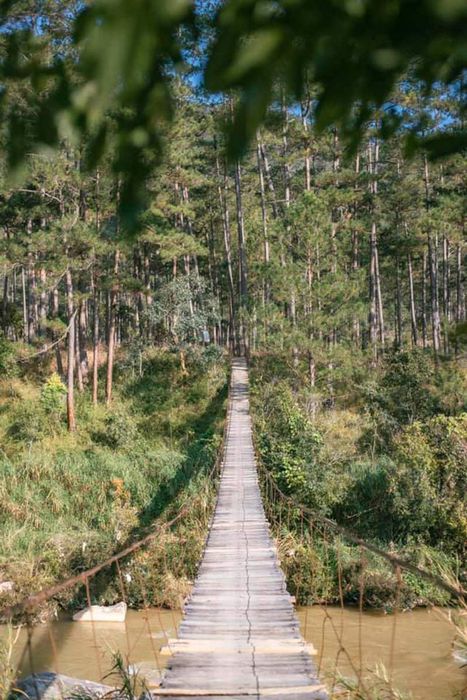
253,352,467,609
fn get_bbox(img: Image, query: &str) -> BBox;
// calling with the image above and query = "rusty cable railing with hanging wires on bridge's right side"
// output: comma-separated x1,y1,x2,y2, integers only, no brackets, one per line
256,450,467,700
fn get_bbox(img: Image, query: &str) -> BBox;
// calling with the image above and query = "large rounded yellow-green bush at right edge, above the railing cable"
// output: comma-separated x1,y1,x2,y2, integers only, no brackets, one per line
333,414,467,553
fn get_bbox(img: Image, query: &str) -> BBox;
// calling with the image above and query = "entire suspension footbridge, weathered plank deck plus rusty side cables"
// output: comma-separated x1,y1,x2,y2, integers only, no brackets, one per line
0,358,467,700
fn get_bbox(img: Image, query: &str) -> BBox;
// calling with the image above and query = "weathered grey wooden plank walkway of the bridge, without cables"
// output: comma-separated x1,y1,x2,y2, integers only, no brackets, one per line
152,359,328,700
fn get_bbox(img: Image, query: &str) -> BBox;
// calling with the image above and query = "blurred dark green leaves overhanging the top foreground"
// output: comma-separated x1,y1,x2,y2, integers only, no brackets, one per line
0,0,467,217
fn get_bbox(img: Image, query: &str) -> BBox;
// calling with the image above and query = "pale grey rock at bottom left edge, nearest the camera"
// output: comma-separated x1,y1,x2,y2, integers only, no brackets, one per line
12,672,115,700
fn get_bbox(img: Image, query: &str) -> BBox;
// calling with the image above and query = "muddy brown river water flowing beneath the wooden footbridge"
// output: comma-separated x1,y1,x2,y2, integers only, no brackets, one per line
0,607,467,700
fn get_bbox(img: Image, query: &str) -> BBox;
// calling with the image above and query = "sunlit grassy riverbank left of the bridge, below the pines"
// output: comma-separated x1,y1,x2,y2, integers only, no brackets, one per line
0,350,227,610
